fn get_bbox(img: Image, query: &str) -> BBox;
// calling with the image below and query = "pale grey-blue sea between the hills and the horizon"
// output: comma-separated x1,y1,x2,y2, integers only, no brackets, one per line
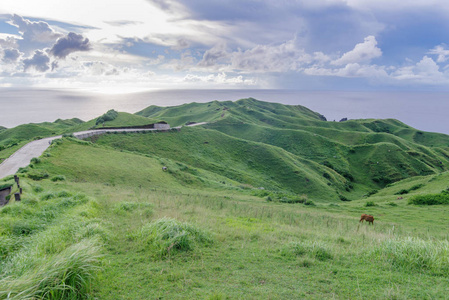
0,89,449,134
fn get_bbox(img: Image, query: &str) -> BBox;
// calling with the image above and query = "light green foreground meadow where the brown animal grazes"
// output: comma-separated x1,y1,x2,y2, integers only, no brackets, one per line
0,141,449,299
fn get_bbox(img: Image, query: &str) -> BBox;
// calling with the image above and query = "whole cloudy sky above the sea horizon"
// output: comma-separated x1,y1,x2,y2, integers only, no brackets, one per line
0,0,449,93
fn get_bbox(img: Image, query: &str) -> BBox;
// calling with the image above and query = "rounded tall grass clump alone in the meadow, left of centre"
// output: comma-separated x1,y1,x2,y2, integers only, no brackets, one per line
136,218,212,257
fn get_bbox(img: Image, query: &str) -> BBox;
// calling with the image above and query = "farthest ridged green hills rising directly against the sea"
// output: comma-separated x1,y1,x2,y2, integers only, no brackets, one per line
130,98,449,198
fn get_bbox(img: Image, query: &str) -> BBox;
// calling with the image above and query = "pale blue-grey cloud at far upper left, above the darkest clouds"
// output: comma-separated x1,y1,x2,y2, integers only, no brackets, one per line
10,15,62,44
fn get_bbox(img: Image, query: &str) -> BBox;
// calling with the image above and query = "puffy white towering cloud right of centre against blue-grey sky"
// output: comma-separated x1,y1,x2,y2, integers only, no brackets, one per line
332,35,382,66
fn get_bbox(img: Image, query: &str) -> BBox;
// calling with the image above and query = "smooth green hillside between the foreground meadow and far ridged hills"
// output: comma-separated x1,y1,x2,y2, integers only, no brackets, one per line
88,128,348,201
